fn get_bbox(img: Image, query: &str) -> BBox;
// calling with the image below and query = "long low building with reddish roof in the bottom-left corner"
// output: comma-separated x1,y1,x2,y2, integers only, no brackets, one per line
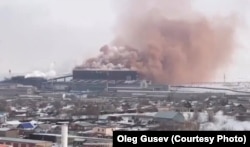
0,137,53,147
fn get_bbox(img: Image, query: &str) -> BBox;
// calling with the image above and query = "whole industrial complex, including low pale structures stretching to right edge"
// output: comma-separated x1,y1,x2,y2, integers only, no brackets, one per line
0,68,250,98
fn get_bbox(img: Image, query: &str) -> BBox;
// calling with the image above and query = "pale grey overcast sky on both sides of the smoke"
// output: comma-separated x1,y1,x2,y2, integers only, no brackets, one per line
0,0,250,80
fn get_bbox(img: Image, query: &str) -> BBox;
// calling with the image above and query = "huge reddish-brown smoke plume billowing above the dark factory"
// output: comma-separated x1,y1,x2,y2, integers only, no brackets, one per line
80,0,236,84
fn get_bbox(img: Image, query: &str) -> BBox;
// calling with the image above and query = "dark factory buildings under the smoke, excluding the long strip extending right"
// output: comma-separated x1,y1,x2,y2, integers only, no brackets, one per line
0,69,169,95
